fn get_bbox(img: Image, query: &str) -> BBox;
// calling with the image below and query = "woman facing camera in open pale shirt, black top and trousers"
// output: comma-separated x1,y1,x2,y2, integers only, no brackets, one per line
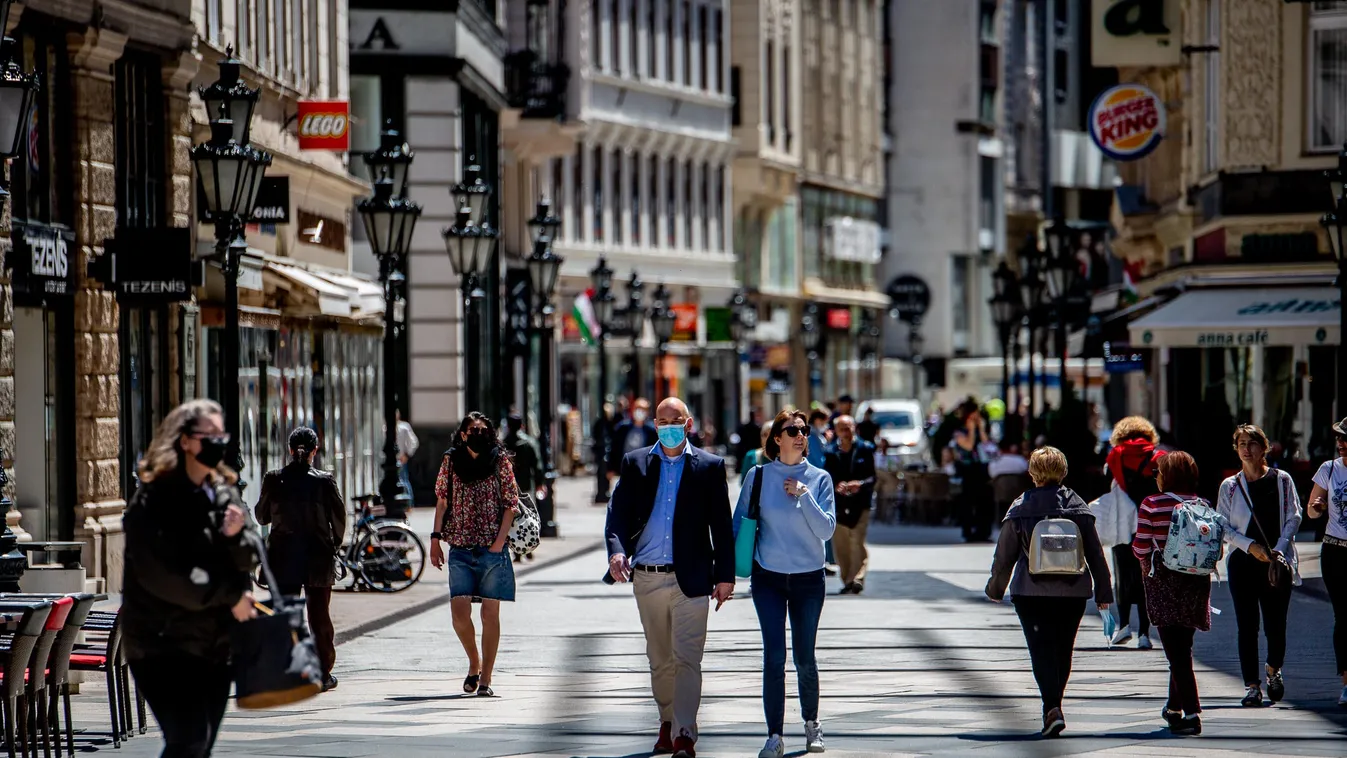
1216,424,1300,707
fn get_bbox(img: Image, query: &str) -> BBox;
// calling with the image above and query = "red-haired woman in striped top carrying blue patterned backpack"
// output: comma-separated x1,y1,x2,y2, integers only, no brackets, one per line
1131,451,1227,735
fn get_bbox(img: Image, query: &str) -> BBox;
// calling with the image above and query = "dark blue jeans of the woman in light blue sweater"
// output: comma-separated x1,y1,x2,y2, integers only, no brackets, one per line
752,563,826,736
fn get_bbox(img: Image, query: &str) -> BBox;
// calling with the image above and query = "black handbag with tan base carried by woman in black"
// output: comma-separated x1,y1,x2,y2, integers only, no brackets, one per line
230,530,323,710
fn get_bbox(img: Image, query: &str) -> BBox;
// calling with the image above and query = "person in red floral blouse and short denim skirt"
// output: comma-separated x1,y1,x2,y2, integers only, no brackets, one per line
430,411,519,697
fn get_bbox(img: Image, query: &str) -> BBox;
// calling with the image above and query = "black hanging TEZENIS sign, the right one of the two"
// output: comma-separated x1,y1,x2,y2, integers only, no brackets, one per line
89,229,205,303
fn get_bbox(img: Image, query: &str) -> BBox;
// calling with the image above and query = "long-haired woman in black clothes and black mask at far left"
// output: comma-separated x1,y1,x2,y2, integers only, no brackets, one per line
121,400,256,757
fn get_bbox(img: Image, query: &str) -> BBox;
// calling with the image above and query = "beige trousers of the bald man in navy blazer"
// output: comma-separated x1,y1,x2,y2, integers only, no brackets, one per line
632,571,711,740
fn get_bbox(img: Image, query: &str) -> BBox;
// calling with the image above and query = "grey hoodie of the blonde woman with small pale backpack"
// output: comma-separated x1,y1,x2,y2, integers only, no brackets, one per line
986,485,1113,603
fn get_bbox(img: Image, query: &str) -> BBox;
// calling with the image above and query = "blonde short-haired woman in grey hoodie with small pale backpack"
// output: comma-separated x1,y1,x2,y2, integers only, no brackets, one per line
986,447,1113,736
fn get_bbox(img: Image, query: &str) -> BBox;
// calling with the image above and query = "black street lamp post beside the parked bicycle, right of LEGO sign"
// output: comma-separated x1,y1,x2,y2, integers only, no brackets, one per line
358,128,422,513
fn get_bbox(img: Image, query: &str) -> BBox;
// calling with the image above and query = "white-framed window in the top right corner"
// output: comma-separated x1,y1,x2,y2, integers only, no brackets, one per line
1308,1,1347,149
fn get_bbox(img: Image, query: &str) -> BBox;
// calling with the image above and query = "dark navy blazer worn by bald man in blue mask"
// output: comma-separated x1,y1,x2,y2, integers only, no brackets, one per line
603,444,734,598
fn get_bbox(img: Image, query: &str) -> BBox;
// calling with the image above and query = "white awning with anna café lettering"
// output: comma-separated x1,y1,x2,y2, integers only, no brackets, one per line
1127,287,1342,347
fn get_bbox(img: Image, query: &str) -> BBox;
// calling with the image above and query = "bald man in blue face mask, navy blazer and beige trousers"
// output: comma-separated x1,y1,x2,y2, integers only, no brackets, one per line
605,397,734,758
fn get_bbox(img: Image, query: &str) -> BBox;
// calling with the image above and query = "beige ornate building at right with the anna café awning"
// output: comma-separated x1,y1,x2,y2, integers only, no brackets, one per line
1113,0,1347,466
